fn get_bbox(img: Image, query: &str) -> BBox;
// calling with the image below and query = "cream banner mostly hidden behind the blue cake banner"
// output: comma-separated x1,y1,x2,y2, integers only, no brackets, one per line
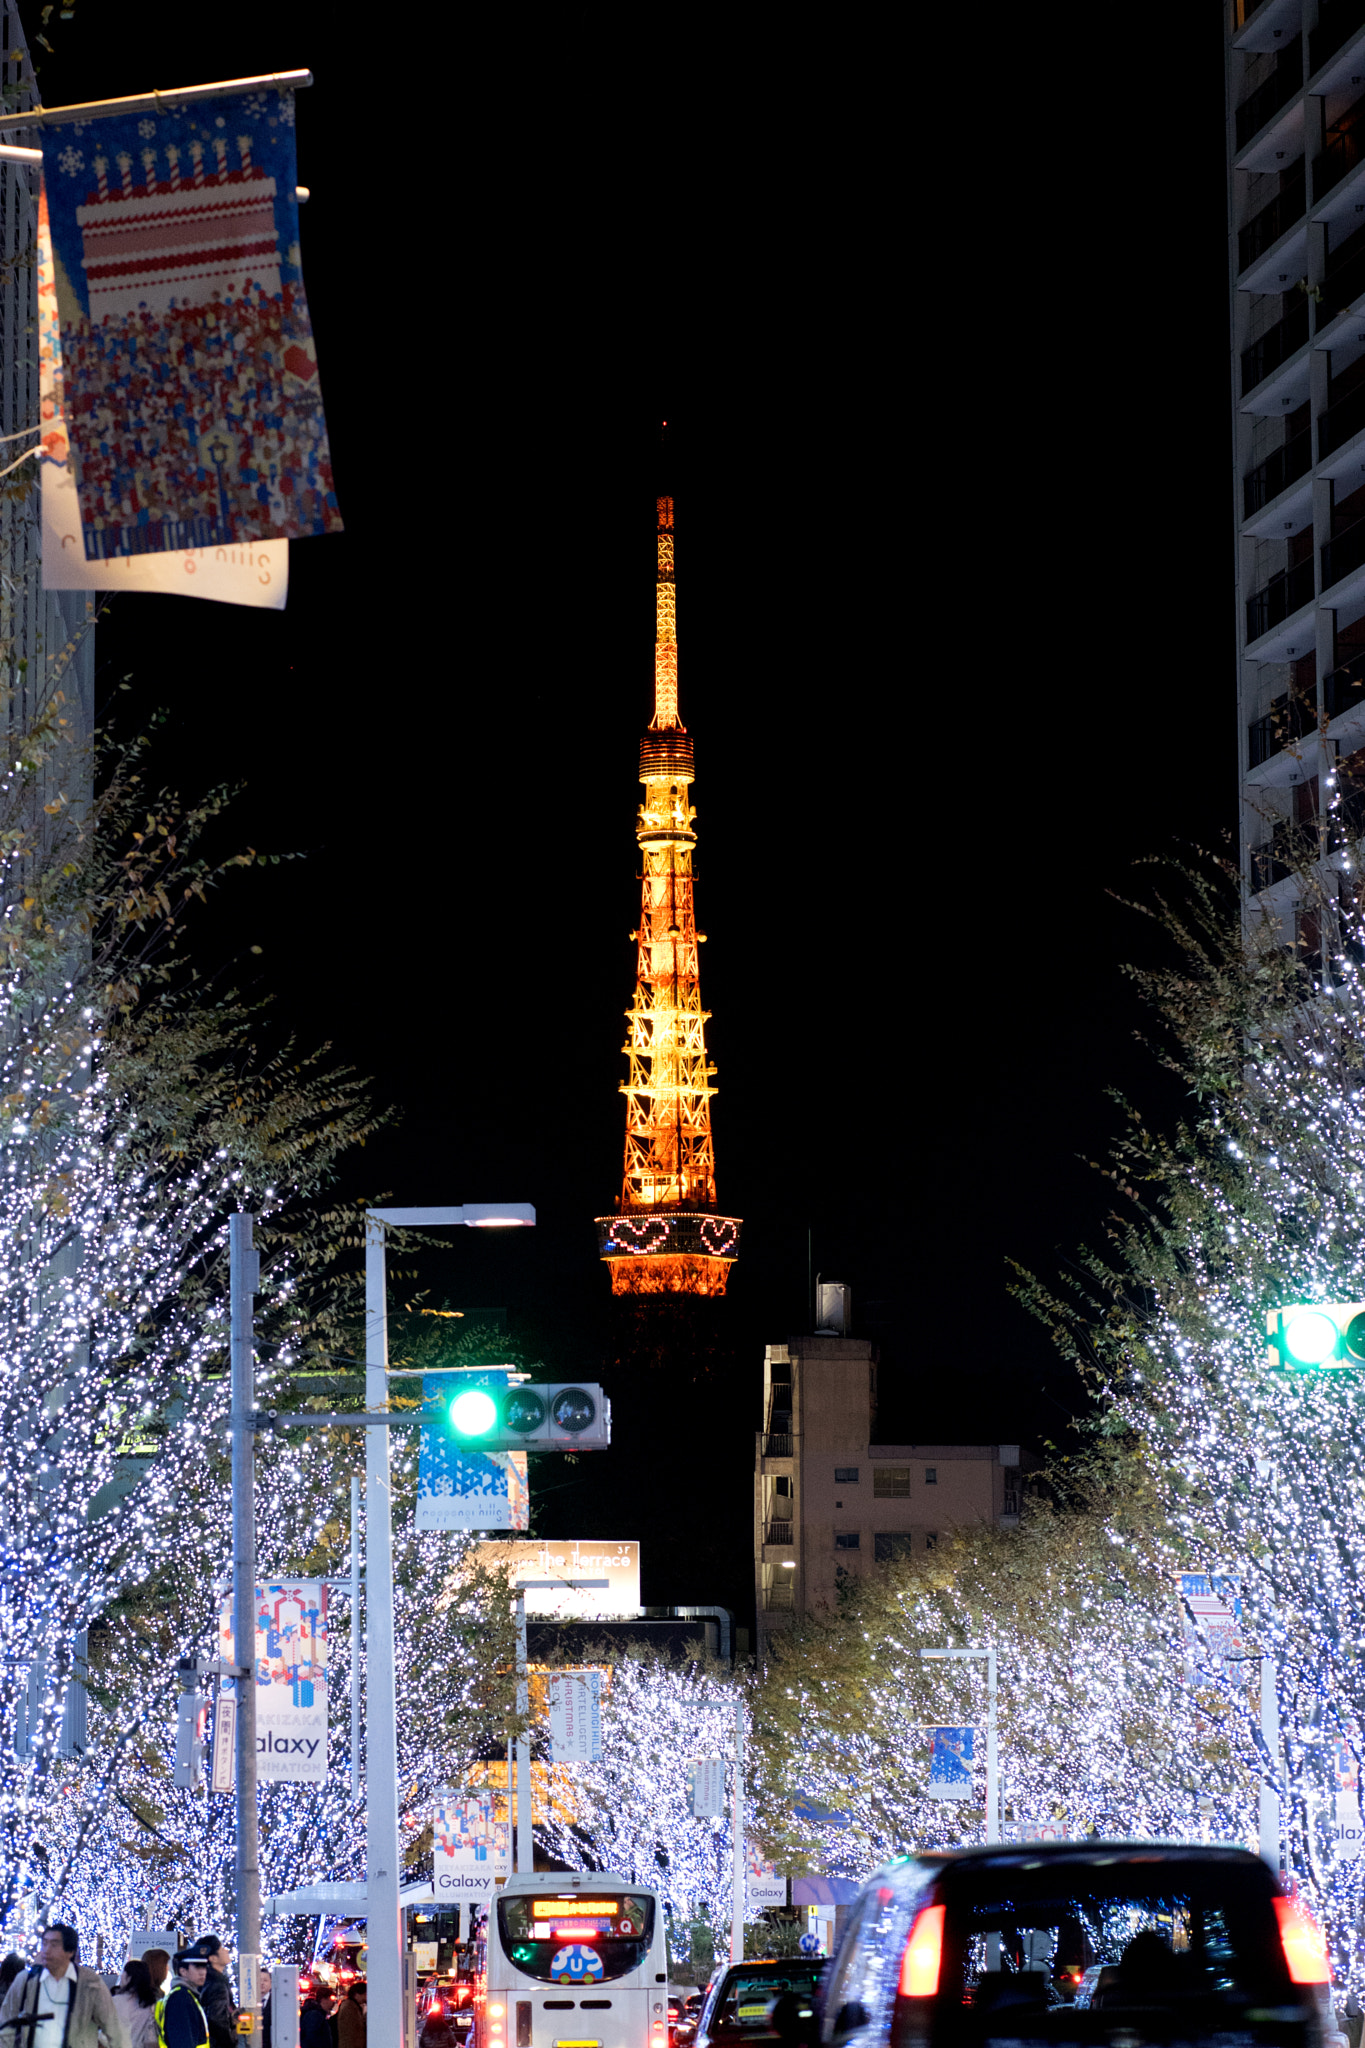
37,186,289,612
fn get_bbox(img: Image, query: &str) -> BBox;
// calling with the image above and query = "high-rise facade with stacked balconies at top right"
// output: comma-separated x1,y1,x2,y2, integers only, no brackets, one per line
1226,0,1365,929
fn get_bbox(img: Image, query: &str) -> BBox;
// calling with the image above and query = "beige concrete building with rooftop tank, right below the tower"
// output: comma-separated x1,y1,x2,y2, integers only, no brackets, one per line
753,1318,1033,1653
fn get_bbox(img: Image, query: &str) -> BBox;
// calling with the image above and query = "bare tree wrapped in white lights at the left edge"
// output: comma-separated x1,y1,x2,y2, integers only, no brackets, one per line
0,698,394,1925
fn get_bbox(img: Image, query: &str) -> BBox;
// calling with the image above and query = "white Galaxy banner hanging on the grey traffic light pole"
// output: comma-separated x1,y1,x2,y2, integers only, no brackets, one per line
219,1579,327,1784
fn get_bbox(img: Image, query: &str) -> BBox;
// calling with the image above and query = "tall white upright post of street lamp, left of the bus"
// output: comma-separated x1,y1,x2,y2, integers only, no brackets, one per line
364,1217,403,2048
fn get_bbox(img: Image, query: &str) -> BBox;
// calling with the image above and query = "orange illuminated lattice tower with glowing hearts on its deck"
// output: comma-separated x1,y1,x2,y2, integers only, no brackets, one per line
598,475,739,1294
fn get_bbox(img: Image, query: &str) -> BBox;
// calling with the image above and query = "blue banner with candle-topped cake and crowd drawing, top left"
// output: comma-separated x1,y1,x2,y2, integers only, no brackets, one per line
43,90,342,561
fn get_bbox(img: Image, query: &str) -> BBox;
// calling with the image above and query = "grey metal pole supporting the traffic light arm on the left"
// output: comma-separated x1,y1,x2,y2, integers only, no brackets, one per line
227,1214,260,2032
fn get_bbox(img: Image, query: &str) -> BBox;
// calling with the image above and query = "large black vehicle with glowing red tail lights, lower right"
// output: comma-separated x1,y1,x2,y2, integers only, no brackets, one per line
812,1841,1340,2048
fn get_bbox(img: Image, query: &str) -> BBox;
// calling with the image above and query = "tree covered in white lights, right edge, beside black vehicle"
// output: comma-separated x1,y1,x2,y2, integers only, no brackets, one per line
1021,827,1365,1980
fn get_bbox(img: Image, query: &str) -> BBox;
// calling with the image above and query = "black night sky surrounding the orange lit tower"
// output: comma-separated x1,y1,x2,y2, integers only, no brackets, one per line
23,0,1236,1620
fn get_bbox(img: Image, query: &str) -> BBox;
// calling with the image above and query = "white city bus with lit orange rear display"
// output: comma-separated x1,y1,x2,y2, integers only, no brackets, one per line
479,1872,669,2048
